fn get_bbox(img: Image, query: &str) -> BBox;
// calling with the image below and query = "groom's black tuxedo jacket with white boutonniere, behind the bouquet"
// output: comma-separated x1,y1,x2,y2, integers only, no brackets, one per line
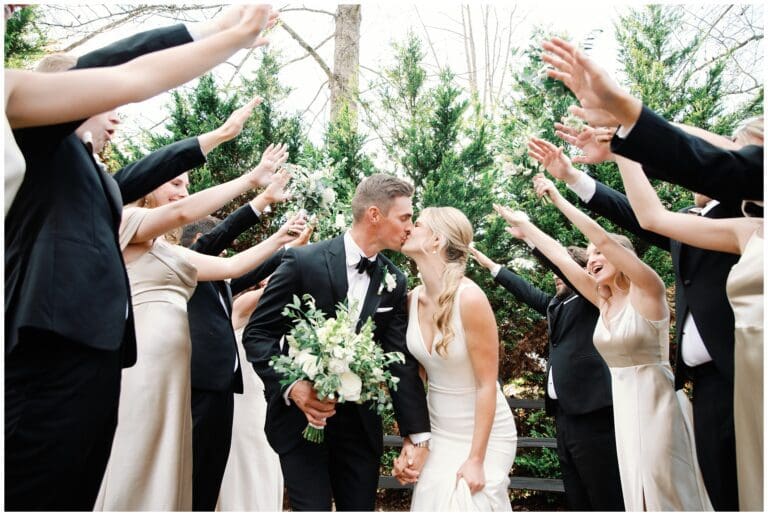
243,236,430,454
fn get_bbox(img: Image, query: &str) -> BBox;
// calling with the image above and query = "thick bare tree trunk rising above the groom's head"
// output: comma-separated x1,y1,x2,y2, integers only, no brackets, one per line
330,4,361,127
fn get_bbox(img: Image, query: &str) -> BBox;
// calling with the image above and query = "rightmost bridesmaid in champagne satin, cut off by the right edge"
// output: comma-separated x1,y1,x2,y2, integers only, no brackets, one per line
616,156,764,511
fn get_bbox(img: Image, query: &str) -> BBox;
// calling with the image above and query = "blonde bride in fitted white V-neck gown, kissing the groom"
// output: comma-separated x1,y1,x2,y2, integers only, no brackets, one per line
394,208,517,511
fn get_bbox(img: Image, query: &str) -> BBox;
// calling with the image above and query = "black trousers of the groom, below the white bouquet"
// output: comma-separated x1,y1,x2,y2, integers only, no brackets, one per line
280,404,381,511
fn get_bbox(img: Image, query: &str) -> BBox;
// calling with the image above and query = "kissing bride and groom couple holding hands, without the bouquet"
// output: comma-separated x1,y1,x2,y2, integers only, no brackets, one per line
243,174,516,511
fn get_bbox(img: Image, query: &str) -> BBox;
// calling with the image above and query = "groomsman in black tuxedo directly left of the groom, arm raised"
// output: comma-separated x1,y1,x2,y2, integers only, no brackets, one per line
181,163,296,511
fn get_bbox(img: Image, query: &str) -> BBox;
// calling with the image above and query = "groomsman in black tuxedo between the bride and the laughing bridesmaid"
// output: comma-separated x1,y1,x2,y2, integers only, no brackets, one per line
472,244,624,511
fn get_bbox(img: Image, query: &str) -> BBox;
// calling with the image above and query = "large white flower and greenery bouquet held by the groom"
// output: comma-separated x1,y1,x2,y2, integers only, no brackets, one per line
270,294,405,443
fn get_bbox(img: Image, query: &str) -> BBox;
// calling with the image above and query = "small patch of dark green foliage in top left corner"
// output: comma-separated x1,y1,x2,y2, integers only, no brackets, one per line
5,5,48,68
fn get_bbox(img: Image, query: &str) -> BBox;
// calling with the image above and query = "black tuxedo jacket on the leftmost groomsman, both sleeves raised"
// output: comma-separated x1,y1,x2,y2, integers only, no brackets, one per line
5,25,196,365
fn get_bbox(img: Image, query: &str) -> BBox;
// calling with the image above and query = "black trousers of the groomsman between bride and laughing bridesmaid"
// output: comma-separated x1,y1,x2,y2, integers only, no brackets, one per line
555,405,624,511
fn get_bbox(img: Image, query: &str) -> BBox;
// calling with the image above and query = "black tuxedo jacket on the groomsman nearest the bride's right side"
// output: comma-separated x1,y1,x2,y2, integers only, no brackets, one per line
496,253,613,416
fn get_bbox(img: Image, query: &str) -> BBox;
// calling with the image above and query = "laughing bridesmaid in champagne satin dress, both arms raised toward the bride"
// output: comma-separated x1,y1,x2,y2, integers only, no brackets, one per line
497,175,712,511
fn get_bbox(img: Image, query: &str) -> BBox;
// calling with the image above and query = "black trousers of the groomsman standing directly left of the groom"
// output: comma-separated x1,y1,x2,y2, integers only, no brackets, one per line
192,385,234,511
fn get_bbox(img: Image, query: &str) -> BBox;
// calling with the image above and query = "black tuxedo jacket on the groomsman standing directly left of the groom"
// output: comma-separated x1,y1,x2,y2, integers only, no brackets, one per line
187,204,282,393
